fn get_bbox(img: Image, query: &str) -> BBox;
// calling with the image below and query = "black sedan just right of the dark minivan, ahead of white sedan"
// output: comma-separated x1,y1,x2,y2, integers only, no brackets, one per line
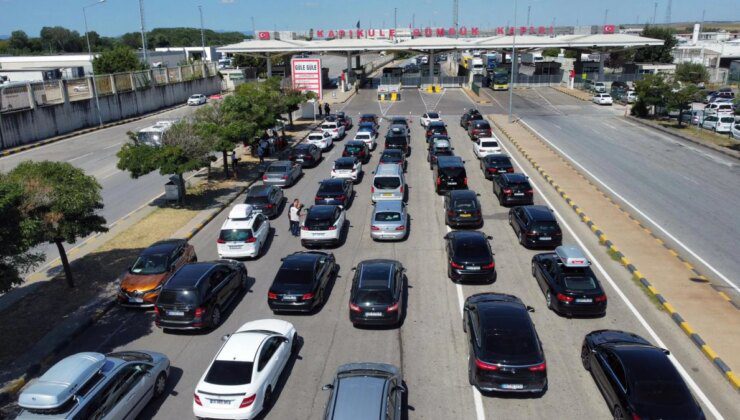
267,251,339,313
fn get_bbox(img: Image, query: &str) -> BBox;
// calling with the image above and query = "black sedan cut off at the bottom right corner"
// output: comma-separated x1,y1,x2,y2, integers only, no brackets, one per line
581,330,705,420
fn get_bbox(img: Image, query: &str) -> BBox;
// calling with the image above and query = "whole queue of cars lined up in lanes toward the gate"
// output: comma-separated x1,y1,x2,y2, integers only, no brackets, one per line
13,110,703,419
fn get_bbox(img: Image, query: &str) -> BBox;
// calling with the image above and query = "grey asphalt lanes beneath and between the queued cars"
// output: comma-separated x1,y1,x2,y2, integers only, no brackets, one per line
42,90,740,419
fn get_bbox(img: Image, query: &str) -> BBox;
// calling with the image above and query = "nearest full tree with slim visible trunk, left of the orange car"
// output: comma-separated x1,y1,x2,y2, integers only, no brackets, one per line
8,161,108,287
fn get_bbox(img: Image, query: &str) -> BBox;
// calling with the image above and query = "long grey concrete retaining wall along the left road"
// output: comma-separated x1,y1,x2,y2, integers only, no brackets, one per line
0,76,221,150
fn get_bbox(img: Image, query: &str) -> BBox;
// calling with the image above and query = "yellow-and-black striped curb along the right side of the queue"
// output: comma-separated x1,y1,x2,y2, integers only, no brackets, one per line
489,119,740,391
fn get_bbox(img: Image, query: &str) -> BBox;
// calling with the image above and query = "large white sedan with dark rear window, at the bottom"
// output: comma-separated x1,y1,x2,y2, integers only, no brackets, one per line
193,319,298,419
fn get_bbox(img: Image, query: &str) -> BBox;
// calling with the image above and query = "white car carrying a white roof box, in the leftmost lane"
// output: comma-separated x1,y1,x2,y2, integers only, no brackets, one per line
216,204,271,258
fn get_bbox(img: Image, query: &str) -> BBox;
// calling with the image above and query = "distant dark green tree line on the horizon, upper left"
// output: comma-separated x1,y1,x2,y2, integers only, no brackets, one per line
0,26,248,55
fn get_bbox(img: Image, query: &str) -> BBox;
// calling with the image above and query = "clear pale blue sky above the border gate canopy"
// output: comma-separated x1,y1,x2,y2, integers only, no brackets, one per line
0,0,740,36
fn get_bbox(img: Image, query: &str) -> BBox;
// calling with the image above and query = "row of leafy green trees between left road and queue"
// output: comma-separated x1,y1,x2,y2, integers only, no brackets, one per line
118,77,313,200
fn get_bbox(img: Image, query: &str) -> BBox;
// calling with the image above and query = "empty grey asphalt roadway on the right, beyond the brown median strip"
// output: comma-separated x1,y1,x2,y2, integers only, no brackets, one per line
488,88,740,290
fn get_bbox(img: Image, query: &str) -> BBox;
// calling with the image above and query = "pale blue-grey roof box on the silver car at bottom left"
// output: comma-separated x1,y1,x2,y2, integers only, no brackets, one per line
18,352,105,410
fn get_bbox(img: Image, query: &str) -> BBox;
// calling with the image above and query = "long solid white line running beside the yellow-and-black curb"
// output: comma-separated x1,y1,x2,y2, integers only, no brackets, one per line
501,132,724,420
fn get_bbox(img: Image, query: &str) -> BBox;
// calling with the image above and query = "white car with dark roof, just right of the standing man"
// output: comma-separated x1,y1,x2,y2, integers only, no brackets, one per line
301,205,347,248
